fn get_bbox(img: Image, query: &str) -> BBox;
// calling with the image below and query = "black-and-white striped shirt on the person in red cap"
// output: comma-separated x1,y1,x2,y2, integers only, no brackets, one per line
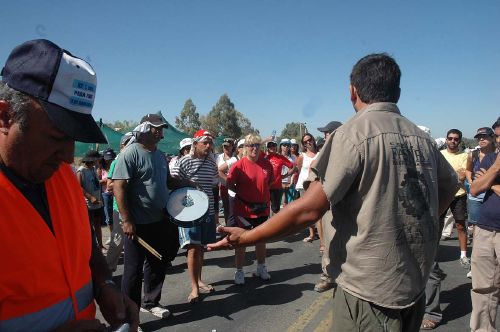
171,154,219,215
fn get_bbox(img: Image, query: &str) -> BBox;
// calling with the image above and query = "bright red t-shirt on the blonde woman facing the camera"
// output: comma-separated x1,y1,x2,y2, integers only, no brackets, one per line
226,157,273,218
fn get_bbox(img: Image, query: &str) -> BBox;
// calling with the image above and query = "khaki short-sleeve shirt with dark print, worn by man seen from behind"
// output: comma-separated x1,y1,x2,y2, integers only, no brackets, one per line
312,103,458,308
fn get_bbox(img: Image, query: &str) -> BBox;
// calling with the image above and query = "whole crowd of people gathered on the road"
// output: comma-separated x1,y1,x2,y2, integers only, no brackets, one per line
0,40,500,331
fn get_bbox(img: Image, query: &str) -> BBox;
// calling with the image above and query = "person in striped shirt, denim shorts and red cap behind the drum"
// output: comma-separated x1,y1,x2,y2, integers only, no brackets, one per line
172,129,219,303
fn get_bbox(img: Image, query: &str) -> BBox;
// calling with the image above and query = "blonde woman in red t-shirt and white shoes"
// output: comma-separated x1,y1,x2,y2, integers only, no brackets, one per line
226,134,273,285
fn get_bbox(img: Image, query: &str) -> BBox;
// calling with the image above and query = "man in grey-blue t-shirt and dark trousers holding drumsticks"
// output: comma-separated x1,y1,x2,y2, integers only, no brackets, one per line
113,114,179,318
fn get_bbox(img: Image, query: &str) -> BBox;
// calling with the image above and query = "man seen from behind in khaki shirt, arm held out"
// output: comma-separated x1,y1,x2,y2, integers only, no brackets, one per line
209,54,458,331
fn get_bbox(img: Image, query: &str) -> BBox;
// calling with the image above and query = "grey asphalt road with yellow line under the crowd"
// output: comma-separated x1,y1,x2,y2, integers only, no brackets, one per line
98,229,492,332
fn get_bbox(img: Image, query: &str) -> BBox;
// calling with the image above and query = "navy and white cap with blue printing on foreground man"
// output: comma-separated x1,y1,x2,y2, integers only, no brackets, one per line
2,39,107,143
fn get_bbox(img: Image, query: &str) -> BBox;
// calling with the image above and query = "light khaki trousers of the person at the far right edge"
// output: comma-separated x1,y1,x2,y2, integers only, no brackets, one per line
470,226,500,331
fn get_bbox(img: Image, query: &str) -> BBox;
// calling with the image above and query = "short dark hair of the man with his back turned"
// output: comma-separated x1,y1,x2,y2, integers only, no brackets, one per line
351,53,401,104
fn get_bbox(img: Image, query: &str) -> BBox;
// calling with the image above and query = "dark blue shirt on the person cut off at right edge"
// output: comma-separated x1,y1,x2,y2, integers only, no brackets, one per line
477,153,500,231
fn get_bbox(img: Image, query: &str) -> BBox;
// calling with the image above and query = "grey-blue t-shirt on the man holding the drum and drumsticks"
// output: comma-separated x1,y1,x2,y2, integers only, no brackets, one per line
113,143,169,224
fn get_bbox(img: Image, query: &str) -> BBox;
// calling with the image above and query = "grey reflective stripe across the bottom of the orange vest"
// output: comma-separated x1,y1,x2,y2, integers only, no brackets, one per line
0,282,94,332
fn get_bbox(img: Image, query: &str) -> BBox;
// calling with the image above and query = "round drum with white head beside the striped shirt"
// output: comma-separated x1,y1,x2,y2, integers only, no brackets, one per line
167,187,209,227
